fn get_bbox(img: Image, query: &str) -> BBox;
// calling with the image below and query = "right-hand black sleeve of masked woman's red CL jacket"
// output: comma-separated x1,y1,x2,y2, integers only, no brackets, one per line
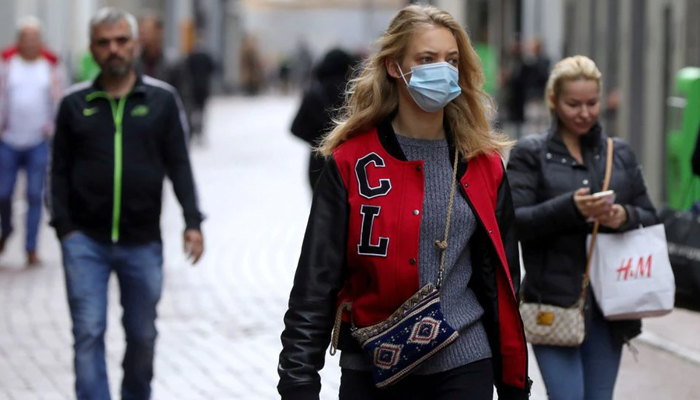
496,161,520,296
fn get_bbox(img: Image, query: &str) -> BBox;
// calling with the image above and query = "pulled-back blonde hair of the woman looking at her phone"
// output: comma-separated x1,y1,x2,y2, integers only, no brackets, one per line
544,56,602,112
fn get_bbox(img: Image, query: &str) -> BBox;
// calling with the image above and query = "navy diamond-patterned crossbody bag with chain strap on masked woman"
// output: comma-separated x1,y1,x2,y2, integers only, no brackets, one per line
331,153,459,388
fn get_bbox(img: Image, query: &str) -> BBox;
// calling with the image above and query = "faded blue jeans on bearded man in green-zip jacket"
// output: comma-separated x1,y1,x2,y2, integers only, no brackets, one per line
61,232,163,400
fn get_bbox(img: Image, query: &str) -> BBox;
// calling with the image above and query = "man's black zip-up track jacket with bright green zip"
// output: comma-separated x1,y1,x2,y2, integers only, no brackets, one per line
47,76,202,244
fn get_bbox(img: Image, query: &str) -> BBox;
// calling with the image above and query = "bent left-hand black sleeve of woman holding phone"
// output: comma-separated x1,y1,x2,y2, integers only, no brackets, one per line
508,139,588,242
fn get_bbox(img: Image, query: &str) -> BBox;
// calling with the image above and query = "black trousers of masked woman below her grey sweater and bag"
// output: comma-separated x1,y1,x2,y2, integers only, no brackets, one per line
340,359,493,400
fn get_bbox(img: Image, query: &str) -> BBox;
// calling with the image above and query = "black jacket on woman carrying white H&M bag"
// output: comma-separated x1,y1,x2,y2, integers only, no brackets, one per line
508,124,658,342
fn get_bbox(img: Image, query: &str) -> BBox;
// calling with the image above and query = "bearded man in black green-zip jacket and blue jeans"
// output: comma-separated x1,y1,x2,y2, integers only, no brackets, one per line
48,8,203,400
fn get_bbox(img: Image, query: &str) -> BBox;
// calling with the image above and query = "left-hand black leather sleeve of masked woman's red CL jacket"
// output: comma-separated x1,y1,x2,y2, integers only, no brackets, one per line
277,159,349,400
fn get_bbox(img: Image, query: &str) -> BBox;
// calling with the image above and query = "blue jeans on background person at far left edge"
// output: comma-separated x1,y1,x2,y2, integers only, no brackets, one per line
0,142,49,251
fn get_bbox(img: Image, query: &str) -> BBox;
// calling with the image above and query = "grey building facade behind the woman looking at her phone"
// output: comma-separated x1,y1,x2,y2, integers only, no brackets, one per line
519,0,700,205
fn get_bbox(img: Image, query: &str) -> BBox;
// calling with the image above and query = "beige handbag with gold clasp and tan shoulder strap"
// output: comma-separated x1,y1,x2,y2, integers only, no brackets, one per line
520,139,613,347
